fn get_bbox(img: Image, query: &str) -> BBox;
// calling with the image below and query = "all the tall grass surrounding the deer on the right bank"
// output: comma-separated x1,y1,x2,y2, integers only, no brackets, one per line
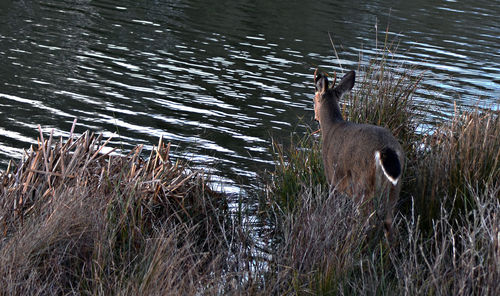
266,41,500,295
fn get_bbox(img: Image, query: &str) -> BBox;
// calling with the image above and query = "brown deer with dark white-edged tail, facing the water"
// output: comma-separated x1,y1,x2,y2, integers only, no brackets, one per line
314,69,405,240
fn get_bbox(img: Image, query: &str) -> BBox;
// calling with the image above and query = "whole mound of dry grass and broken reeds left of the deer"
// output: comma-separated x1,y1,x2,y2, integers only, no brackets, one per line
0,125,237,295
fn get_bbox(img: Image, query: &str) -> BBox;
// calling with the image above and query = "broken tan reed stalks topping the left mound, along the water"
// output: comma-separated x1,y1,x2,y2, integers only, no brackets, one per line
0,129,223,220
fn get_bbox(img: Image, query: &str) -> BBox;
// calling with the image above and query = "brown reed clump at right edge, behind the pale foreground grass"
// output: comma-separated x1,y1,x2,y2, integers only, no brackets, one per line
409,108,500,223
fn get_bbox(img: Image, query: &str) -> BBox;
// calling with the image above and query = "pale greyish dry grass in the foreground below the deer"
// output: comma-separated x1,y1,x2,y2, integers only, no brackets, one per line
265,178,500,295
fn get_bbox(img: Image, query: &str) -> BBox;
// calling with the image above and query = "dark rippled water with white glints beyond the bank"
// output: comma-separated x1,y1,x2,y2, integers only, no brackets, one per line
0,0,500,190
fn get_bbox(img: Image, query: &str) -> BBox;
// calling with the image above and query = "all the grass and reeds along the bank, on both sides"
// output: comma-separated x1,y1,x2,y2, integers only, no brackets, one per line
0,40,500,295
